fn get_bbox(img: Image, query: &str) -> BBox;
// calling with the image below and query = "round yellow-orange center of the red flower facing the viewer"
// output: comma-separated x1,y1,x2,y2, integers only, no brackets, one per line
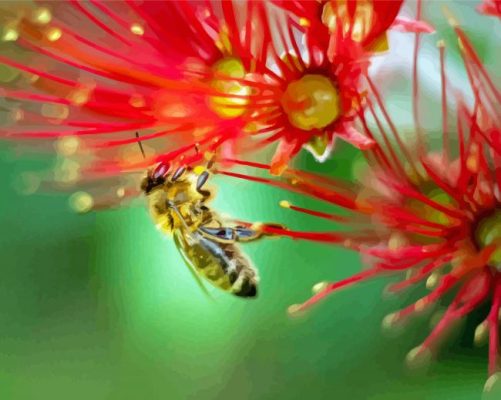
282,74,341,131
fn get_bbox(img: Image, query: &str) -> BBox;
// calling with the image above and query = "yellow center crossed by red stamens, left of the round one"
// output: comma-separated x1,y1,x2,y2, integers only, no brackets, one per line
209,57,250,118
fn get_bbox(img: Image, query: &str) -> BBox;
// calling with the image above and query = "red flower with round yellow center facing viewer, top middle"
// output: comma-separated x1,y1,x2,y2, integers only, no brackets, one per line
230,1,401,174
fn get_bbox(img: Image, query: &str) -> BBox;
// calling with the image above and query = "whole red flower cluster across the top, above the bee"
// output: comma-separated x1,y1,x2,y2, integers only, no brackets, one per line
0,1,401,183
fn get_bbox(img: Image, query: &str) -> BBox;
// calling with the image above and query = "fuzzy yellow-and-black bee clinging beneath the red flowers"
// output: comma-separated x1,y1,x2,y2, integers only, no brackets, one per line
141,163,263,298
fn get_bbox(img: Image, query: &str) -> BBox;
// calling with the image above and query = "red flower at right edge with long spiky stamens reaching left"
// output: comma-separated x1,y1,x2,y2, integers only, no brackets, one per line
221,12,501,389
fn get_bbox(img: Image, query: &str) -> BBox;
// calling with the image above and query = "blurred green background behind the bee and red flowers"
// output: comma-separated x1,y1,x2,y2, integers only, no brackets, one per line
0,2,501,400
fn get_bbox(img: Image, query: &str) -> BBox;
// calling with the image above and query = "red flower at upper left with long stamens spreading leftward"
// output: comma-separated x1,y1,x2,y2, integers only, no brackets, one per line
0,1,267,183
